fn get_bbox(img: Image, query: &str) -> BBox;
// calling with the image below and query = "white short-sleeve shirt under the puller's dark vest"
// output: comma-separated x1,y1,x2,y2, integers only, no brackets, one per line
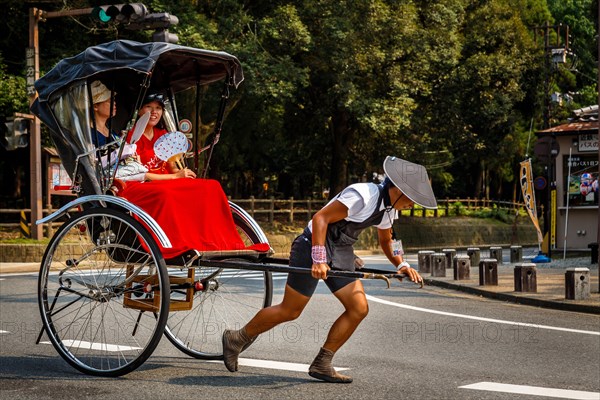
308,183,398,232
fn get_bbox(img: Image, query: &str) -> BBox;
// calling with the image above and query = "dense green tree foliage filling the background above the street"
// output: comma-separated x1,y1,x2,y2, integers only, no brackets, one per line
0,0,597,206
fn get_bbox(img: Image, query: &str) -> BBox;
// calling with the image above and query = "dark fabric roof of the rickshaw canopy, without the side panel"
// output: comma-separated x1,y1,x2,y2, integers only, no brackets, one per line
31,40,244,138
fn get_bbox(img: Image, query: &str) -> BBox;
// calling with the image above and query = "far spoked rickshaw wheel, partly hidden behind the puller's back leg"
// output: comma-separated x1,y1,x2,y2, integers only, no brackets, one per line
165,215,273,360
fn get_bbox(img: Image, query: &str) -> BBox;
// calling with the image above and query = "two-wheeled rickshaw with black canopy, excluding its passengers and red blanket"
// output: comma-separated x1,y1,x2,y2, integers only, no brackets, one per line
31,40,408,376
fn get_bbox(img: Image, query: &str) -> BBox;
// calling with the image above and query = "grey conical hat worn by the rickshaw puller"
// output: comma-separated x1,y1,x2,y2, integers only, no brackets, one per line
383,156,437,208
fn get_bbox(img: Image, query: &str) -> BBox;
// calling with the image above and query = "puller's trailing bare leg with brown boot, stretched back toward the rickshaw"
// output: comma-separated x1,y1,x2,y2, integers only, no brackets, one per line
223,285,310,372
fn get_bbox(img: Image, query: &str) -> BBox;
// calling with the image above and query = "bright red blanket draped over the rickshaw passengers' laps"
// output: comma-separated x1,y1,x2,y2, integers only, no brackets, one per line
119,179,269,259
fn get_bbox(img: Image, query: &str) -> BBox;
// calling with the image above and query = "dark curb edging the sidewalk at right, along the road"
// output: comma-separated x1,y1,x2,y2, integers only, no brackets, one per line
424,278,600,314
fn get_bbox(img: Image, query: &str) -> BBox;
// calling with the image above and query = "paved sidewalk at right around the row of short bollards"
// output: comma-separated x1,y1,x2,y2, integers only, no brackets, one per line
422,258,600,314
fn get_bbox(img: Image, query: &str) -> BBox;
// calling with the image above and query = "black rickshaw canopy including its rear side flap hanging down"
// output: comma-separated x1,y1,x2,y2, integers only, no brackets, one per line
31,40,244,193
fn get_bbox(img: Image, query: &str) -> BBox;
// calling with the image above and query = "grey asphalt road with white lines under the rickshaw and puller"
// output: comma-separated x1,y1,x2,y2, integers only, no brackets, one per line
0,256,600,400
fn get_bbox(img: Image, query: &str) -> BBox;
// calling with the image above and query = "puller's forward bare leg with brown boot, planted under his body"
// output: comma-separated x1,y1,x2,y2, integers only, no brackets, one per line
308,280,369,383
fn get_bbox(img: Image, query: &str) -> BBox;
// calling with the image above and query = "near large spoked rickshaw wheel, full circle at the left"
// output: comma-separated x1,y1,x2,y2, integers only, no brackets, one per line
38,208,169,376
